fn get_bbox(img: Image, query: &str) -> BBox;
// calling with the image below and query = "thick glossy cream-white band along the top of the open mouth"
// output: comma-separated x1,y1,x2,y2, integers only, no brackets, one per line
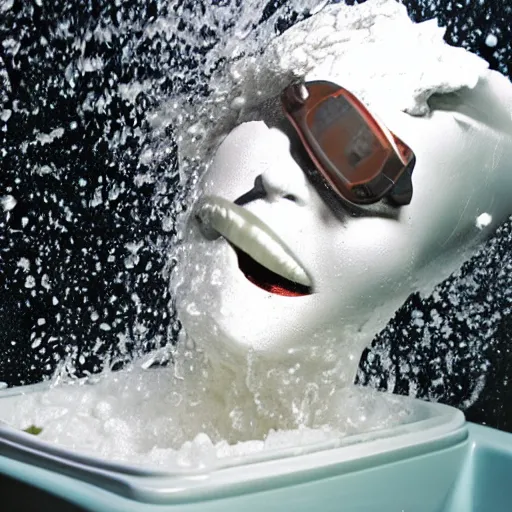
196,196,313,287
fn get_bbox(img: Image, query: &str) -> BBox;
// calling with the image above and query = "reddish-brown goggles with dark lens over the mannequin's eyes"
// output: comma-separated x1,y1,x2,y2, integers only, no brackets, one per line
281,81,416,206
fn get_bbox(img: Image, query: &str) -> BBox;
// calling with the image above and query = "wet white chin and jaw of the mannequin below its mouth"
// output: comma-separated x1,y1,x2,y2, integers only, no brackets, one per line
179,268,359,376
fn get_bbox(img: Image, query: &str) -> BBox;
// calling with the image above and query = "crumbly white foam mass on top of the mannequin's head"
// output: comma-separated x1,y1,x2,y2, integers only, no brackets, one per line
203,0,488,141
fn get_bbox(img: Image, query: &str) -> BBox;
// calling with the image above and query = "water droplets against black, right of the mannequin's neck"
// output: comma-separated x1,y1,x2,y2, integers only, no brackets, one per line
358,214,512,419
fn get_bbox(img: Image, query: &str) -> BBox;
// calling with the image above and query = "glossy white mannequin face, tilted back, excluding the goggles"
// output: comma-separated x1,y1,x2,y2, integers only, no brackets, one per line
178,75,512,382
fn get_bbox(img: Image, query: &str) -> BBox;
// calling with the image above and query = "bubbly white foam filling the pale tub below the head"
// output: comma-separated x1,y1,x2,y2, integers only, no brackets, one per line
1,366,414,468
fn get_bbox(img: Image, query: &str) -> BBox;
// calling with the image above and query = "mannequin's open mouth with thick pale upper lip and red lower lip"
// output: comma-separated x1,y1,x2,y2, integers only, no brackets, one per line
196,196,313,297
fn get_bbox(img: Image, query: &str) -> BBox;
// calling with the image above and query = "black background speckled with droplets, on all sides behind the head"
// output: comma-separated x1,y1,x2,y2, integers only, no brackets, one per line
0,0,512,431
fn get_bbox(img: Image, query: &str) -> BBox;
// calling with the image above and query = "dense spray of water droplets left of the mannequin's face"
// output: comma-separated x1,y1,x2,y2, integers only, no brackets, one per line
0,0,332,384
